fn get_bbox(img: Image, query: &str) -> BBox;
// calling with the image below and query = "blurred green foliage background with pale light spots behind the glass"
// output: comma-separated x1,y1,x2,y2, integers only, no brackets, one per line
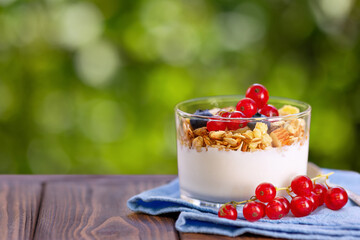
0,0,360,174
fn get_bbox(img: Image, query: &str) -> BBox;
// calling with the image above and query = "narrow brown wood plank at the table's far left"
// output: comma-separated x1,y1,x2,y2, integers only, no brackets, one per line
0,179,41,239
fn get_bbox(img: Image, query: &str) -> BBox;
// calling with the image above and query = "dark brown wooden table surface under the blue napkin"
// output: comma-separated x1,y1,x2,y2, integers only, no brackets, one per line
0,175,276,239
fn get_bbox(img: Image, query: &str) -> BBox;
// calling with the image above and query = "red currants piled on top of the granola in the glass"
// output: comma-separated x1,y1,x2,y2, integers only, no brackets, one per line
206,84,279,131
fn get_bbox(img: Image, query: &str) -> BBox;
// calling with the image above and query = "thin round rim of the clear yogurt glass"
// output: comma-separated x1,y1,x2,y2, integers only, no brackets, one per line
175,95,311,121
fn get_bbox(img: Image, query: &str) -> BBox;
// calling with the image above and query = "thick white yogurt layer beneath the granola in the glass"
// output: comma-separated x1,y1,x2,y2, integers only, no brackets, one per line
178,141,309,203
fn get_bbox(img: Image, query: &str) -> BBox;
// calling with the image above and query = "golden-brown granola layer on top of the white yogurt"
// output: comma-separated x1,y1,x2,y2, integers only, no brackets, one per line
179,105,306,152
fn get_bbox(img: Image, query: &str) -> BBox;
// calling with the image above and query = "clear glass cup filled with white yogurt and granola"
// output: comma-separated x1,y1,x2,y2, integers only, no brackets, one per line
175,95,311,207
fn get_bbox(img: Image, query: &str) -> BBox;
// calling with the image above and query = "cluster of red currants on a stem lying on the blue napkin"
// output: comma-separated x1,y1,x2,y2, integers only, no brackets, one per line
218,173,348,222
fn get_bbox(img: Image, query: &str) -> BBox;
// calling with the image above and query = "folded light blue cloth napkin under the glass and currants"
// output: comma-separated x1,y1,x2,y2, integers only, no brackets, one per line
127,169,360,239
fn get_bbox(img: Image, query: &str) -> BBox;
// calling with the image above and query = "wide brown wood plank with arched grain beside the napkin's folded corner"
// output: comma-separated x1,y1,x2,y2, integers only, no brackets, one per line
34,176,178,239
